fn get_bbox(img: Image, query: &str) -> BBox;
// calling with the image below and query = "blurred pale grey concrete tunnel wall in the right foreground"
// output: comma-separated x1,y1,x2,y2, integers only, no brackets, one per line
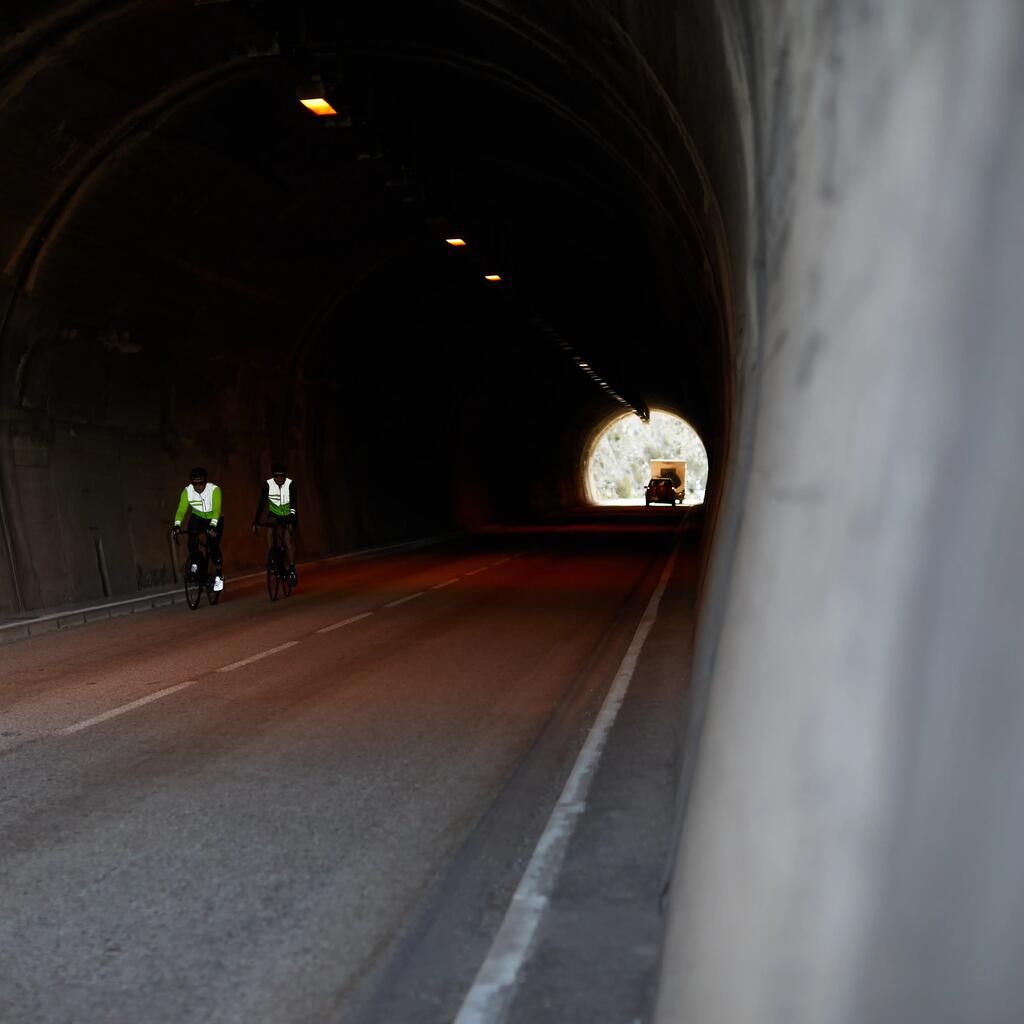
656,0,1024,1024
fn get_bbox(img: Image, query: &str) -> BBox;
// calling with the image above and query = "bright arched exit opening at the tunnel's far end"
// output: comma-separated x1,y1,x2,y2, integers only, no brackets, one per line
586,410,708,505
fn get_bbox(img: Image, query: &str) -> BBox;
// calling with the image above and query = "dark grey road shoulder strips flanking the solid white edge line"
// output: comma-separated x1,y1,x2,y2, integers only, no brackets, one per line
350,540,697,1024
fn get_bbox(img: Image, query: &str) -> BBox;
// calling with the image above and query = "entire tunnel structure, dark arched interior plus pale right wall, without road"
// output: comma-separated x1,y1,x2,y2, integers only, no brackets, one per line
0,0,1024,1022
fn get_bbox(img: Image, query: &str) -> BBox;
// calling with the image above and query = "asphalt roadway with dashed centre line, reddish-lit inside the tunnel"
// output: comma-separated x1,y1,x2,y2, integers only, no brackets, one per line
0,510,678,1024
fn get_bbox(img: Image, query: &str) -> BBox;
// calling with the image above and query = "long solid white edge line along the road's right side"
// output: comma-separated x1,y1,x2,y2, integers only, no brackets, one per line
454,543,679,1024
